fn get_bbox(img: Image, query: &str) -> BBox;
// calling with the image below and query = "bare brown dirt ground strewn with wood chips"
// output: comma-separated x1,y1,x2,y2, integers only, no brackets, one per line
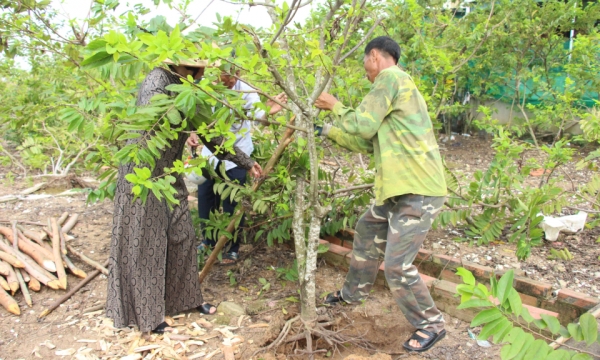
0,137,600,360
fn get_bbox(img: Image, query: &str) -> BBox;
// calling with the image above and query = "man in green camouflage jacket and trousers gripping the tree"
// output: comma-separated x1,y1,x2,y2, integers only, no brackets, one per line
315,36,446,351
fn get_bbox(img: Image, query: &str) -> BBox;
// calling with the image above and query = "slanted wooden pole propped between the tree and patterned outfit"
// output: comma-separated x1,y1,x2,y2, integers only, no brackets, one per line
198,117,295,283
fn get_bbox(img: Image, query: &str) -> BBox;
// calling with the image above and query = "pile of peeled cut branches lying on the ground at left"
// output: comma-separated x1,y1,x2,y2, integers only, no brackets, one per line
0,213,108,315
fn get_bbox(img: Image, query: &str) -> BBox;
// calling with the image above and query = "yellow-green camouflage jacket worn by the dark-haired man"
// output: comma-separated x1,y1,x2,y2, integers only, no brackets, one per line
327,66,446,205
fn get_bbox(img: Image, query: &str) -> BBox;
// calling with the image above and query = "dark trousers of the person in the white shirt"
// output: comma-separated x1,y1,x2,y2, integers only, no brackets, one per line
198,167,247,253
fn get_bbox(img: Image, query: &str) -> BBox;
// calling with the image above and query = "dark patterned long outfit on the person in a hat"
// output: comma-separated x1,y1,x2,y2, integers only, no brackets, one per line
106,68,254,331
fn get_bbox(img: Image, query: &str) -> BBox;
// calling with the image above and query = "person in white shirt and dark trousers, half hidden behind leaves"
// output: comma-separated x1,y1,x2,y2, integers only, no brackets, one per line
188,59,287,265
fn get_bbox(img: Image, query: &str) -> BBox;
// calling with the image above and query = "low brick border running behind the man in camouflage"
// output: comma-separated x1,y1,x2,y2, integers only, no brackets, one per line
321,230,600,324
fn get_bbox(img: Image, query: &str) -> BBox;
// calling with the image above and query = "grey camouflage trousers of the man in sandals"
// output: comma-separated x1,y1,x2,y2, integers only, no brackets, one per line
342,195,444,333
